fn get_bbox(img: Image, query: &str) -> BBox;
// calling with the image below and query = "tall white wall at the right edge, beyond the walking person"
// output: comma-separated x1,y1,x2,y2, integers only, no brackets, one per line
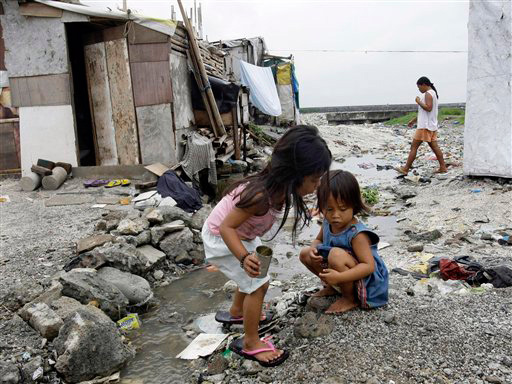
464,0,512,178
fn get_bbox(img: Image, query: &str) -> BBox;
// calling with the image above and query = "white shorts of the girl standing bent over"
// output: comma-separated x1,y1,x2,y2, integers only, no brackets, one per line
201,221,270,293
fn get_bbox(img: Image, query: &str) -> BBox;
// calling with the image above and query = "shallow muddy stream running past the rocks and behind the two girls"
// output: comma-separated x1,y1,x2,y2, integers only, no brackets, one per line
122,155,396,384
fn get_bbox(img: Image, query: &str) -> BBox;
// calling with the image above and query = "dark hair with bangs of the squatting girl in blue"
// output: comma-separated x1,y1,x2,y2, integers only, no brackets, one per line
316,169,370,216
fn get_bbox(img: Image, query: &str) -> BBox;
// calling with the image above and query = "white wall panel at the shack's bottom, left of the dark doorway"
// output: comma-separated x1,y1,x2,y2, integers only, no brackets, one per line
19,105,78,175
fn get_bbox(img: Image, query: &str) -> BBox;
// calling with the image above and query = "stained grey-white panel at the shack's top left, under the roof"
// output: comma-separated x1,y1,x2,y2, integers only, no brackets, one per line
0,1,69,77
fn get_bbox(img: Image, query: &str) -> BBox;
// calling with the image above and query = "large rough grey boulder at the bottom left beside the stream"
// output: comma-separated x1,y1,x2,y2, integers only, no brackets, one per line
54,306,135,383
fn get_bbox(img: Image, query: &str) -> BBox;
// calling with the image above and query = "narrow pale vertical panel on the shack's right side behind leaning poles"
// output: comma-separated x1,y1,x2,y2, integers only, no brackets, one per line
170,51,195,161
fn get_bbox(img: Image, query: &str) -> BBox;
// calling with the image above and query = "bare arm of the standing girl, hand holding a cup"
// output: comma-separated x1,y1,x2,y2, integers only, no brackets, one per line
219,200,261,277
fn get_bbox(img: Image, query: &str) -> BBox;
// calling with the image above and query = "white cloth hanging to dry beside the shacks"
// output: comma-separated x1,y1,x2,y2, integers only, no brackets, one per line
240,61,282,116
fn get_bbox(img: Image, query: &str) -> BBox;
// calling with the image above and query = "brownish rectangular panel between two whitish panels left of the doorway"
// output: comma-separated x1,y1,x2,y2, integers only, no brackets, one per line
10,73,71,107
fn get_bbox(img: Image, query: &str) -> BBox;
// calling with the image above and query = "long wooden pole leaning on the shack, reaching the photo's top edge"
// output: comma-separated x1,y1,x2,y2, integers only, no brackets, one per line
178,0,226,137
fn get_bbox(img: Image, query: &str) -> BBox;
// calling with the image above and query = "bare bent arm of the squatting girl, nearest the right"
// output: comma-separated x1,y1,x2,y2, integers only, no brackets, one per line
320,232,375,285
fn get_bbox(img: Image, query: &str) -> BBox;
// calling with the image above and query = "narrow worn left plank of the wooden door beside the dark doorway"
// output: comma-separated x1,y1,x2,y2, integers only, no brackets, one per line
84,43,118,165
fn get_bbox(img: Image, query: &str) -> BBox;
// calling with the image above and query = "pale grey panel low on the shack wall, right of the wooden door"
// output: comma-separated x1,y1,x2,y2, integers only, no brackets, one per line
136,104,176,165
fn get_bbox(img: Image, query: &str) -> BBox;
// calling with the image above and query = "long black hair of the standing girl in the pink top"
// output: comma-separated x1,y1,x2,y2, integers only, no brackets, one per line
224,125,332,239
